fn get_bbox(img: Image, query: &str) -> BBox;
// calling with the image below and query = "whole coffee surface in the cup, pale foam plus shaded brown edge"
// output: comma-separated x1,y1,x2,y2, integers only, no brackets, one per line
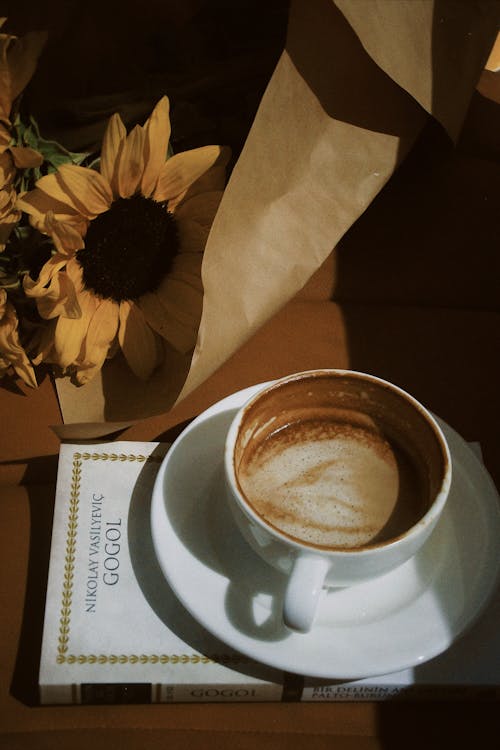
236,407,427,549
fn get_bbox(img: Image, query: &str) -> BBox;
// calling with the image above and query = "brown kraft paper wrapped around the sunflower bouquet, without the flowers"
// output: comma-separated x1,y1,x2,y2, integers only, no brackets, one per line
52,0,500,439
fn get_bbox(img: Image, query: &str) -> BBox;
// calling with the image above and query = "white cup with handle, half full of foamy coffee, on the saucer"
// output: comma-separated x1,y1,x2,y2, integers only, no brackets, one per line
224,369,451,632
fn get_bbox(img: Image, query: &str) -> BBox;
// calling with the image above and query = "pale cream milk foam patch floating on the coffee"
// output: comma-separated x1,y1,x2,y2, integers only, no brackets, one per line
239,422,404,548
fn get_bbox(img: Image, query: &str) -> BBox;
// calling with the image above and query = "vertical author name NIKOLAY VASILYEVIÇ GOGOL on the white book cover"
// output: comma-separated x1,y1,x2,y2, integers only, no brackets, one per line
85,493,122,612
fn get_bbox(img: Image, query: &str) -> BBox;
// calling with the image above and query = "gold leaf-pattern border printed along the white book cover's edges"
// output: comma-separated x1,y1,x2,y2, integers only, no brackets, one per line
56,452,246,665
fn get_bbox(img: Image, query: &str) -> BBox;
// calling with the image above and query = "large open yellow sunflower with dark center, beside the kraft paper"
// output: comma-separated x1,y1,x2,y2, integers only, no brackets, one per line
17,97,229,385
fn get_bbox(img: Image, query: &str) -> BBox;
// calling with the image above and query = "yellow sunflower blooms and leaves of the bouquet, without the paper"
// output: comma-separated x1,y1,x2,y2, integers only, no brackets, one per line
0,18,229,394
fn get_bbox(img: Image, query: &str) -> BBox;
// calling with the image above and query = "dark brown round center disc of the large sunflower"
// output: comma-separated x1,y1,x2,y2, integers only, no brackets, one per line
76,195,179,302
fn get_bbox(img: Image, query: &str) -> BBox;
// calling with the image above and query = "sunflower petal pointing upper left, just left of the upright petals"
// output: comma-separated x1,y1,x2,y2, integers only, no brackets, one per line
58,164,113,218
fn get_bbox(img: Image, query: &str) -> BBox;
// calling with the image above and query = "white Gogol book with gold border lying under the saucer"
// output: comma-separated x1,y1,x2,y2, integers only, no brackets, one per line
39,441,500,704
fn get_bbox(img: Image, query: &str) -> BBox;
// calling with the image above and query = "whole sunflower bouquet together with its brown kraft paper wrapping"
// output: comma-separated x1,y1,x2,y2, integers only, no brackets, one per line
0,0,498,436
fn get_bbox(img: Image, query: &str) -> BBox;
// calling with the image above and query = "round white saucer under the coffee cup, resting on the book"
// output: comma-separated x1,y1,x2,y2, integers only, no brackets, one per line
151,386,500,679
